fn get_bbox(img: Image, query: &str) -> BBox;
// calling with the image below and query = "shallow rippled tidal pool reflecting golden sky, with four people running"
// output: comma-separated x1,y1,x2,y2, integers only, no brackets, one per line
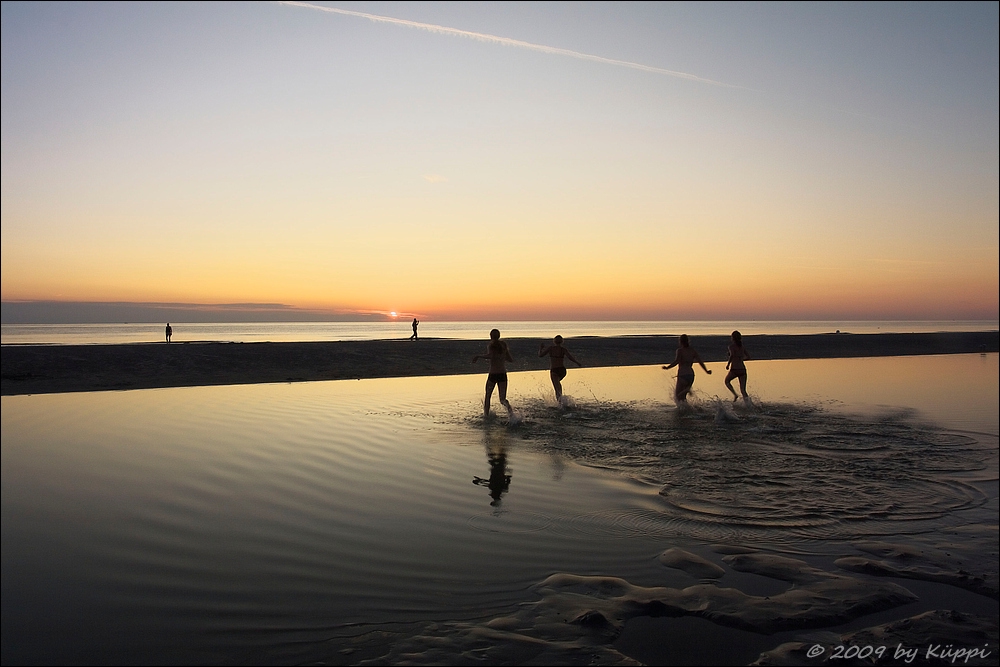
2,354,1000,664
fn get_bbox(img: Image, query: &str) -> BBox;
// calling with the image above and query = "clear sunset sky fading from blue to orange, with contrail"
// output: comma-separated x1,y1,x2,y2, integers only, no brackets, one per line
0,2,1000,320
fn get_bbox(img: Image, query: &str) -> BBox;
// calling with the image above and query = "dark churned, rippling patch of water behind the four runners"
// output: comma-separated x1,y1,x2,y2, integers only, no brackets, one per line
500,400,996,543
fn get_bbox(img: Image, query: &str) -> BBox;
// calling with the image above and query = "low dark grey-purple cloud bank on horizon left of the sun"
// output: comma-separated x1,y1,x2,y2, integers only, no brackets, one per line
0,301,388,324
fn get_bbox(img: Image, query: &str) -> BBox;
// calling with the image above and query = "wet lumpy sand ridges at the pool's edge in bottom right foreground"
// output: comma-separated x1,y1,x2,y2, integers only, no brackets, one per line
342,545,1000,665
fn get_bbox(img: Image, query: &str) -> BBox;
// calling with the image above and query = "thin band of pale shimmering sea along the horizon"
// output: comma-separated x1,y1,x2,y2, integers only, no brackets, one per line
0,319,1000,345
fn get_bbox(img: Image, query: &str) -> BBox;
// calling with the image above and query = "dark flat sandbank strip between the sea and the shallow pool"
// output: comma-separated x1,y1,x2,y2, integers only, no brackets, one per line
0,331,1000,396
